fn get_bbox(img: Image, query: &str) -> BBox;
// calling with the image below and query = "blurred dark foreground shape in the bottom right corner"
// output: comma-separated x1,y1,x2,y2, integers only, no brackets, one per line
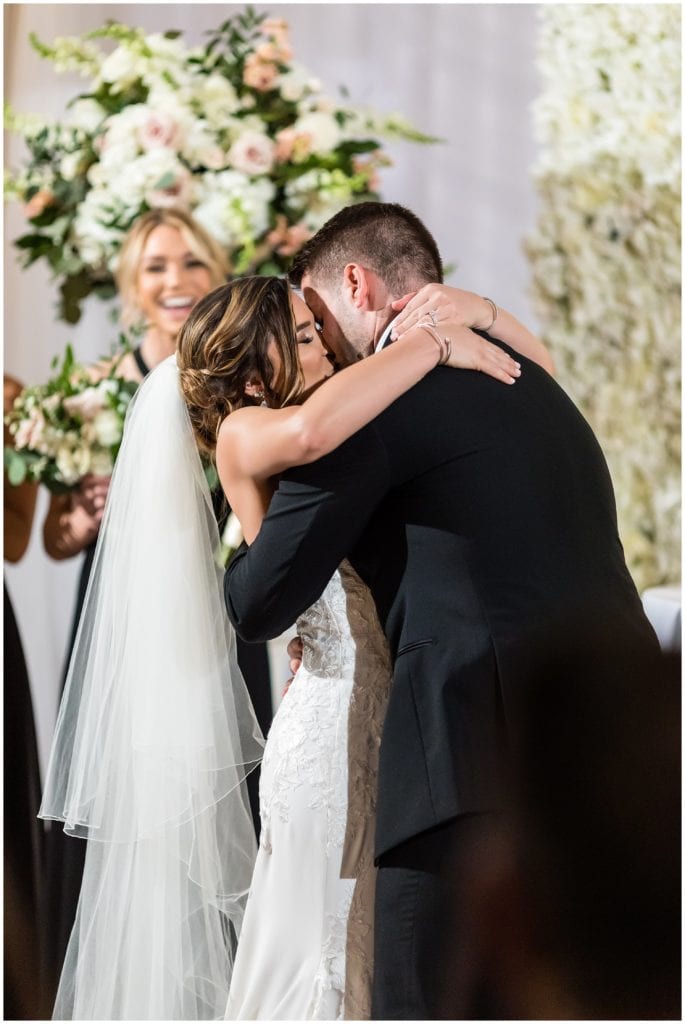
441,630,681,1020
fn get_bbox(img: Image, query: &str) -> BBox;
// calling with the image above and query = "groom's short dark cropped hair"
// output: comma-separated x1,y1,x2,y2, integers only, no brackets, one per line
290,203,442,295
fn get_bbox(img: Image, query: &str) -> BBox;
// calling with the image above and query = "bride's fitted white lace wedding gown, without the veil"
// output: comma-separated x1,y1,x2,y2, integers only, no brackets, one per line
225,562,391,1020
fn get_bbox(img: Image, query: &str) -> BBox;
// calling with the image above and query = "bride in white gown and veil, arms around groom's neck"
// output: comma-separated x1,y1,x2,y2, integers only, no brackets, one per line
41,278,544,1020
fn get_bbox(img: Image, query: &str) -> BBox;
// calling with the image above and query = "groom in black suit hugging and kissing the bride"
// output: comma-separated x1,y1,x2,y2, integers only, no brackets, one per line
225,203,655,1020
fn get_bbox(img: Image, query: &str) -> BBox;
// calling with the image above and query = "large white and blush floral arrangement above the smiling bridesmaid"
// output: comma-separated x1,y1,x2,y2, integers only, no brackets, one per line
6,8,435,323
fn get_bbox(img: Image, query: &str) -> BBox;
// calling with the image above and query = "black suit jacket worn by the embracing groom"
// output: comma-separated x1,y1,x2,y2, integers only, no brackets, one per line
224,346,655,854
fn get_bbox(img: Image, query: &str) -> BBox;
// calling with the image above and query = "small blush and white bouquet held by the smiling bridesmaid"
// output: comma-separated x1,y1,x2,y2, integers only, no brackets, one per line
5,339,137,494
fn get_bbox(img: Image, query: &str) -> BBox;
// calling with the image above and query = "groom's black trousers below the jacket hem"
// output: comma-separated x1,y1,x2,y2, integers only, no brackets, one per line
372,814,498,1020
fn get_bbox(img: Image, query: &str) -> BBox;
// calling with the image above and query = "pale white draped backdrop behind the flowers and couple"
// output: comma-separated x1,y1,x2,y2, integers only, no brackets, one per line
4,3,539,764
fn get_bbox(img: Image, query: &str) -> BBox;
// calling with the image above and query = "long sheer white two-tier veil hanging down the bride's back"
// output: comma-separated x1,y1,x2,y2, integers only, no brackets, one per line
40,356,263,1020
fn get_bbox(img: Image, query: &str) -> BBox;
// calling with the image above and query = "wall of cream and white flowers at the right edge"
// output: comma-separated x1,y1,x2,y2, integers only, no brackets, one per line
527,4,681,589
